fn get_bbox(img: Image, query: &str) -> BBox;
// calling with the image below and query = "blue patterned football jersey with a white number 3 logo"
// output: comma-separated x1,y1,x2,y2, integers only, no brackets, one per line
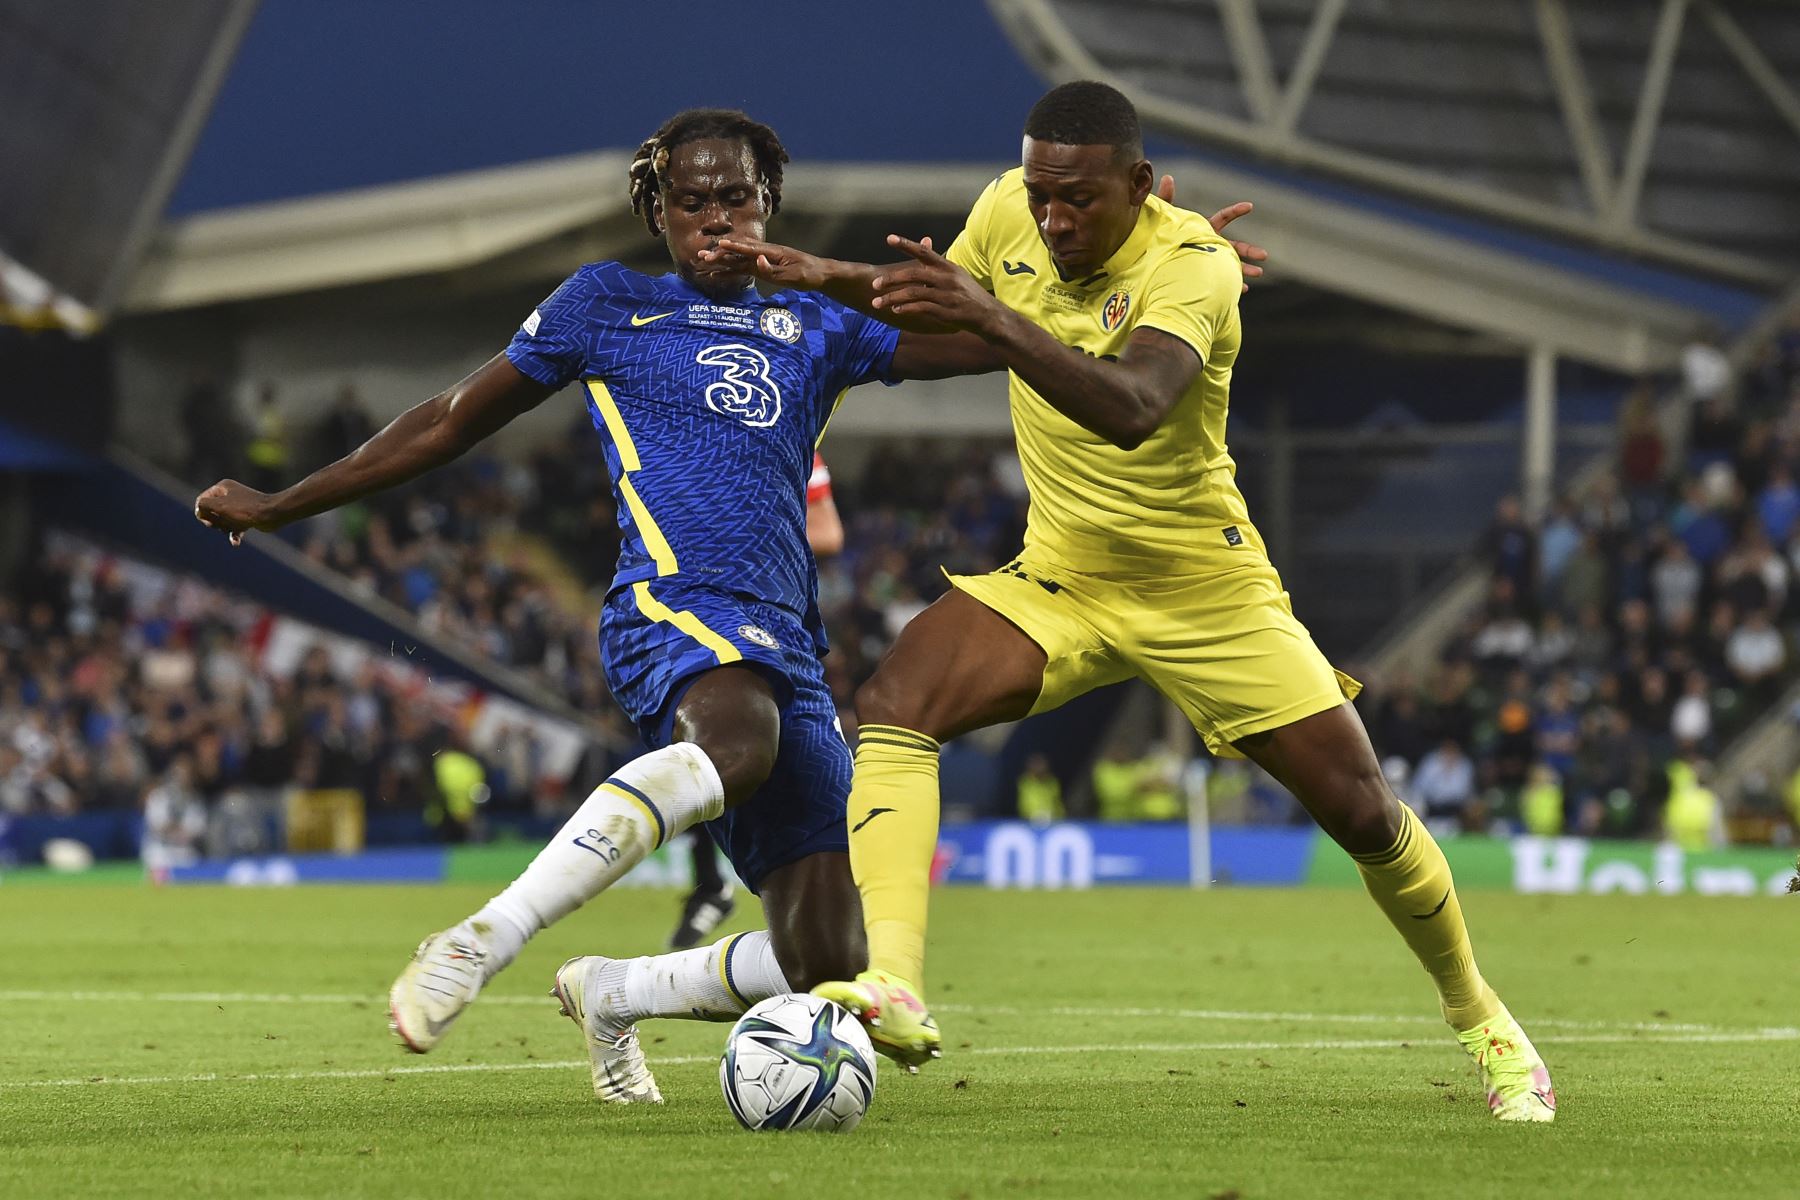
506,263,900,649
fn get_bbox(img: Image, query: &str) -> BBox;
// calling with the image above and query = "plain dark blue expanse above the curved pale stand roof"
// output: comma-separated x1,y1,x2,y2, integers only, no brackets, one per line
169,0,1044,214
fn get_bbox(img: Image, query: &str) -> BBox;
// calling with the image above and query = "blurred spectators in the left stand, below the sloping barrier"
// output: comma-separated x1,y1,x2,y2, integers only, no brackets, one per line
0,534,572,858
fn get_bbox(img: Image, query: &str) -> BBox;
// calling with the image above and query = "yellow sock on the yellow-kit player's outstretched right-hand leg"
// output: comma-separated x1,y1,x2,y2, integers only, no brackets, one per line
1352,808,1499,1033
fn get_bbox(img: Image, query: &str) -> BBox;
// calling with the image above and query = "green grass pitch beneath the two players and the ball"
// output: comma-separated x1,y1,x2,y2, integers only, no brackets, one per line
0,885,1800,1200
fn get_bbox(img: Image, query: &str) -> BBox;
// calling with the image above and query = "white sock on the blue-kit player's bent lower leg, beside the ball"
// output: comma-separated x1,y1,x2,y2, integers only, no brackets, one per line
596,928,792,1024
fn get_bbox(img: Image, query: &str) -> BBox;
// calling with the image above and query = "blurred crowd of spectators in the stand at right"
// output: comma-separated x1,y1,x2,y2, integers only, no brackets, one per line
1364,318,1800,846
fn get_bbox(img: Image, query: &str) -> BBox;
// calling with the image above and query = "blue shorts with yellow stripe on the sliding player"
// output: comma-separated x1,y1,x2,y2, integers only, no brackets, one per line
599,579,850,892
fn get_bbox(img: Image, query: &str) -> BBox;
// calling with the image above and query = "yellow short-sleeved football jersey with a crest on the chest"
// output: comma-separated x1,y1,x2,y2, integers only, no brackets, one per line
947,167,1247,574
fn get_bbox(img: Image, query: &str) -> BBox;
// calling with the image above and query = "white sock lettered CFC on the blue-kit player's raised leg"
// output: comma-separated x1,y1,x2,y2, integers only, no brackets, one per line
468,741,725,979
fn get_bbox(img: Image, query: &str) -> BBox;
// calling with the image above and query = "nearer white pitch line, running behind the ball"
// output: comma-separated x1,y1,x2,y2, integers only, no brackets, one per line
0,1029,1800,1090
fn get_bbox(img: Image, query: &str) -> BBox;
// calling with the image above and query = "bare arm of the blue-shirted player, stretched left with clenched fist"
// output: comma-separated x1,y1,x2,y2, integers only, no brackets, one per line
194,354,556,545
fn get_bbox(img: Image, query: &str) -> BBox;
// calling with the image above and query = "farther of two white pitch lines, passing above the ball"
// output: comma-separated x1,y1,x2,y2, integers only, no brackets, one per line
0,990,1724,1033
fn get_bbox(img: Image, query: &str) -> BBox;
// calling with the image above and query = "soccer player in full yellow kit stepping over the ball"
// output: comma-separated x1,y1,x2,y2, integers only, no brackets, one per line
727,83,1555,1121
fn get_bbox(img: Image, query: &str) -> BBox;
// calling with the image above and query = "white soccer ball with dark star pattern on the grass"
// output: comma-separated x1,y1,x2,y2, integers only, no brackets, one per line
718,995,875,1133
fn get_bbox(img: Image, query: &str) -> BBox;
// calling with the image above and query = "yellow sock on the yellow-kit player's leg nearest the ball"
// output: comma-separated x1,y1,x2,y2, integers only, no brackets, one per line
848,725,938,988
